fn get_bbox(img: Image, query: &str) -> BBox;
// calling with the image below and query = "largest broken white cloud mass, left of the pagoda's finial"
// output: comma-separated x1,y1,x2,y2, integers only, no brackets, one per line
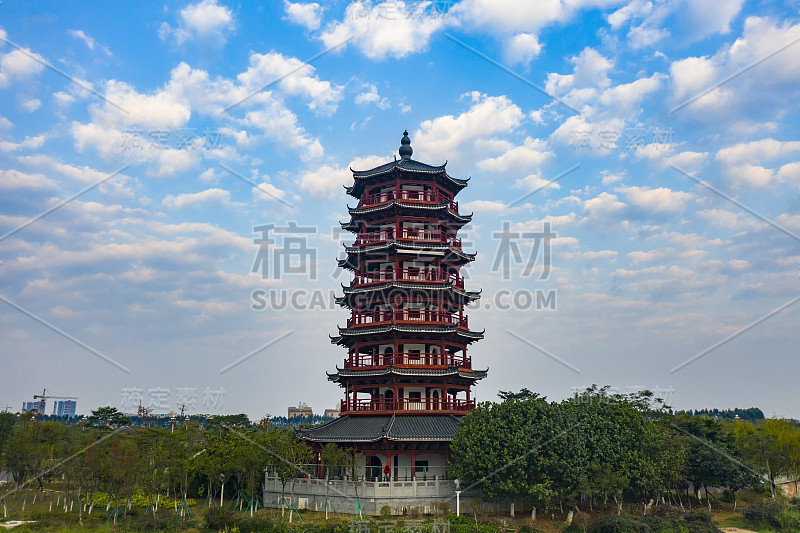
72,58,326,167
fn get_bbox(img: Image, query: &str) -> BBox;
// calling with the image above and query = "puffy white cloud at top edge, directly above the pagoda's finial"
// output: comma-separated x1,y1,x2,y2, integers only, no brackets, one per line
319,1,444,59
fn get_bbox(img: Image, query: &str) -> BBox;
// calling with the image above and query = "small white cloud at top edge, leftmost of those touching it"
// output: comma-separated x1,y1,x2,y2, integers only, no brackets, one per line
158,0,236,45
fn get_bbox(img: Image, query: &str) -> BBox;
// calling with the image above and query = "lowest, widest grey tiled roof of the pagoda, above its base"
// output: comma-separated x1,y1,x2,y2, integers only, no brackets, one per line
297,415,461,442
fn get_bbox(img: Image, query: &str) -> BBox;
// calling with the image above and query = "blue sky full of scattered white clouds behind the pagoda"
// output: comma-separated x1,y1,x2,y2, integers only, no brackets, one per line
0,0,800,417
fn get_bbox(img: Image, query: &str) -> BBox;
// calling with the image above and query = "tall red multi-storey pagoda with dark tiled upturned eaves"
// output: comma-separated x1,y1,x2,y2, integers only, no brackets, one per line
298,131,487,481
